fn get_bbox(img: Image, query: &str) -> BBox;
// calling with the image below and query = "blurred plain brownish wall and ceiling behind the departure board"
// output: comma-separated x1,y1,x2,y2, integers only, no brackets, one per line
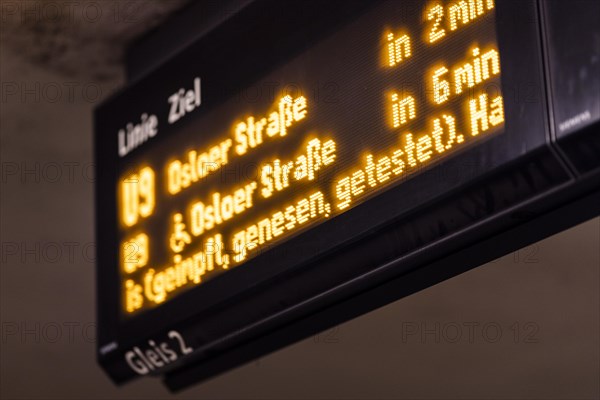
0,0,600,399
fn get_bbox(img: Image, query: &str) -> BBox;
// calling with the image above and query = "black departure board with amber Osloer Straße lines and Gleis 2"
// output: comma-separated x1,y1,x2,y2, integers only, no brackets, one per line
95,0,589,388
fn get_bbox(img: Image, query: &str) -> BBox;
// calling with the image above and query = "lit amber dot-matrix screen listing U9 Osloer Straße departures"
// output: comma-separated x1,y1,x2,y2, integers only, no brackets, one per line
113,0,504,320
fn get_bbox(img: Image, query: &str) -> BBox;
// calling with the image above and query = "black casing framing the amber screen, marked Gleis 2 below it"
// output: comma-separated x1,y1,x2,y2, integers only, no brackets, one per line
95,0,600,390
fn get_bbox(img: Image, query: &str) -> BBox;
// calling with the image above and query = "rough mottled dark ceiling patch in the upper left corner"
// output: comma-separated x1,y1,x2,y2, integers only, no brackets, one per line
0,0,188,80
